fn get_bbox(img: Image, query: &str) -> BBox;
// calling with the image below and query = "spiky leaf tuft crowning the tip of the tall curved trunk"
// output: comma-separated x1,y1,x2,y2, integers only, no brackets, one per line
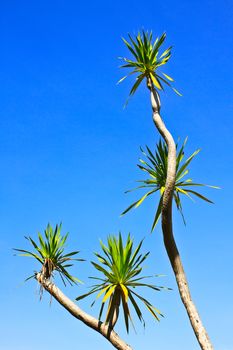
118,31,181,96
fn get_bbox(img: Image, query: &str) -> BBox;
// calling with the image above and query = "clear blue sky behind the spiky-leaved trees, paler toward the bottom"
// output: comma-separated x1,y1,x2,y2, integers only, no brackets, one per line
0,0,233,350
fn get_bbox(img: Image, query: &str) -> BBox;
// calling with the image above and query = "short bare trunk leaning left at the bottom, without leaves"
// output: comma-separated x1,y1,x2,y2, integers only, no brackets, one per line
36,273,132,350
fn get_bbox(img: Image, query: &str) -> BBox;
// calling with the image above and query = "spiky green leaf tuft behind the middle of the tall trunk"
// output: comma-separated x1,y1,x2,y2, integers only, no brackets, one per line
121,138,219,232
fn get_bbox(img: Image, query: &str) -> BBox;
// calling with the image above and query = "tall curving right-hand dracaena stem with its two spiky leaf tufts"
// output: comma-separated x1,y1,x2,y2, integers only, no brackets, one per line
120,31,217,350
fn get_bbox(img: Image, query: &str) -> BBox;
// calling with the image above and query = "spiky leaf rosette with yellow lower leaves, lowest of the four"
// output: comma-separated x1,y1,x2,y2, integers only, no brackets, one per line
76,233,163,332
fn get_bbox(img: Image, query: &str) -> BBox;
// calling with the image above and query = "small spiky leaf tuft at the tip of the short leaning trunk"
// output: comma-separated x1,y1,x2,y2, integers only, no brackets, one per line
14,224,83,285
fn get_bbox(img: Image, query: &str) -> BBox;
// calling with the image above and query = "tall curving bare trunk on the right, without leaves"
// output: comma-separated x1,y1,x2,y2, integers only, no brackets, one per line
147,79,213,350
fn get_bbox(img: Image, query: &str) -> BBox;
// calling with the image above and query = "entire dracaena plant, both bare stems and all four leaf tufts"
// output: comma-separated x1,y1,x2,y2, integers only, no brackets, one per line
15,28,217,350
